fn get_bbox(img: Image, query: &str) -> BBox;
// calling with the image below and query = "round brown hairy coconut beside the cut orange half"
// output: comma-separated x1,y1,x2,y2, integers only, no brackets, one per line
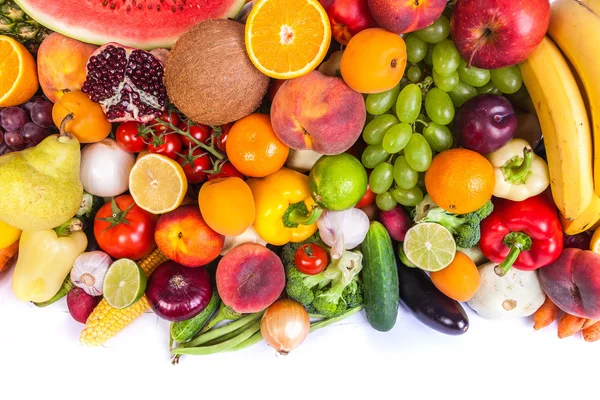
165,19,269,125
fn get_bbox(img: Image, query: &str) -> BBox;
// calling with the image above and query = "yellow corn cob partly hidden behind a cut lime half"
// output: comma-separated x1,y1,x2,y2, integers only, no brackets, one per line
79,247,168,346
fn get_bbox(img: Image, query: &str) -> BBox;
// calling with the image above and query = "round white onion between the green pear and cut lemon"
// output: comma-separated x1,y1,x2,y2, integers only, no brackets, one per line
80,139,135,197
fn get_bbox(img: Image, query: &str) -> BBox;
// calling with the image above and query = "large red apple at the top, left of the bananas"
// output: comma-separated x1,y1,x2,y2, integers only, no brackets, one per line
450,0,550,69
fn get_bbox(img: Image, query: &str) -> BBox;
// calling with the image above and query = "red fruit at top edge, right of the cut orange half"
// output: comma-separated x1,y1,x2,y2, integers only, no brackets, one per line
319,0,377,45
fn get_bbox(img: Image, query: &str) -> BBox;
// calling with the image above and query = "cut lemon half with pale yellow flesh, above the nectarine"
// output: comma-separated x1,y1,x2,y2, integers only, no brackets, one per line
129,154,188,214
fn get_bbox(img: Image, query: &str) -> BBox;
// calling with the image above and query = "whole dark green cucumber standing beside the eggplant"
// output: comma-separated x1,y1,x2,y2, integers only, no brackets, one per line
361,221,400,332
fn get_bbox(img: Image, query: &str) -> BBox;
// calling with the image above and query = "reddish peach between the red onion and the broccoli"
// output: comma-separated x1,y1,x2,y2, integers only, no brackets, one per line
216,243,285,313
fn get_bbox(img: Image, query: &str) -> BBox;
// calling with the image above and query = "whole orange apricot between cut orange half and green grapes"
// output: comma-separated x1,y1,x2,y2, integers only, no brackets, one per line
340,28,406,93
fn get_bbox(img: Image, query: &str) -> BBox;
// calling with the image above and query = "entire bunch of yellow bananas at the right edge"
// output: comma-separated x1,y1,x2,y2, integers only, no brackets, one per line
520,0,600,235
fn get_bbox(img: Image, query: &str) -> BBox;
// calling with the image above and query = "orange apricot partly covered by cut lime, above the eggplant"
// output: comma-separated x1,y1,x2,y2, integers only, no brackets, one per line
429,251,480,301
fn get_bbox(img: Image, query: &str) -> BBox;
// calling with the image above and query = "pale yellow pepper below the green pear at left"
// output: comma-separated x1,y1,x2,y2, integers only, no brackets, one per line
12,219,87,303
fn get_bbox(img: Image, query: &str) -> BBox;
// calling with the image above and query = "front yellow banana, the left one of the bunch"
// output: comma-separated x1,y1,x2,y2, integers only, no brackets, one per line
519,37,594,220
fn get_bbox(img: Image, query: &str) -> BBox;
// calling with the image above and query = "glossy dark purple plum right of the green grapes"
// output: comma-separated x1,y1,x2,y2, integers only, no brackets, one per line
454,94,517,154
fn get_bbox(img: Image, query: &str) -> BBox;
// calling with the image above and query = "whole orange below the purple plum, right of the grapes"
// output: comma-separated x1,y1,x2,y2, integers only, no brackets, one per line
425,149,496,214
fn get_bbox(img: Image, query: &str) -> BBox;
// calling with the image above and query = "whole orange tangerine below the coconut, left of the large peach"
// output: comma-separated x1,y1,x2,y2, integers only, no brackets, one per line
225,114,290,178
